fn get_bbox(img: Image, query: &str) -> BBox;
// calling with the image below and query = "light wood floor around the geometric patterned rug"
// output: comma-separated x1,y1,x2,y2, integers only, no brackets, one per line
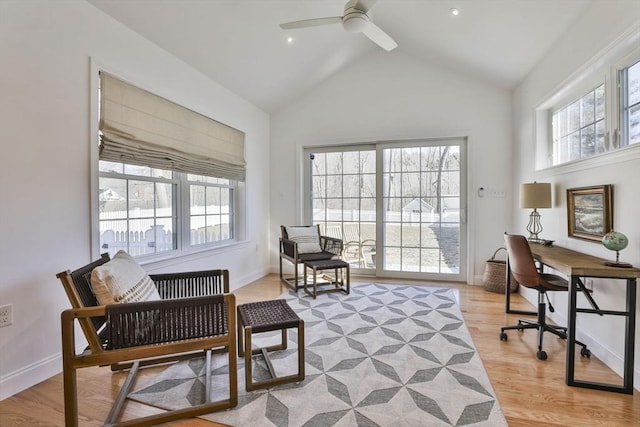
0,275,640,427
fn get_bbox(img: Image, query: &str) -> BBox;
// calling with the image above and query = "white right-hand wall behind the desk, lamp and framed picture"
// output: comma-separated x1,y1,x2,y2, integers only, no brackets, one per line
511,1,640,388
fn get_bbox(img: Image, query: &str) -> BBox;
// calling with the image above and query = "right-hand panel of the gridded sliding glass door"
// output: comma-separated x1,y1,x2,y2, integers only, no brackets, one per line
381,141,466,276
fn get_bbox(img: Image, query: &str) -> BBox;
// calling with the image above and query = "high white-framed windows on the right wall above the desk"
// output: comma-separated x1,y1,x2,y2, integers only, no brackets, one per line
536,29,640,169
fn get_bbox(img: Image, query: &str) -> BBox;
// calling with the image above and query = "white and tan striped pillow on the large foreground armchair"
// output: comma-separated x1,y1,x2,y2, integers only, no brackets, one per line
91,251,160,305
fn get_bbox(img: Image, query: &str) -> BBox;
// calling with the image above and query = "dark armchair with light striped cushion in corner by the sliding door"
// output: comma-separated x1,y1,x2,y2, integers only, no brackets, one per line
280,225,343,292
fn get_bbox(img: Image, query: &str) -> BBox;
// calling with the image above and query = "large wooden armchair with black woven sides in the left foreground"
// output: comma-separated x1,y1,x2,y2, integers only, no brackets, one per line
57,252,238,427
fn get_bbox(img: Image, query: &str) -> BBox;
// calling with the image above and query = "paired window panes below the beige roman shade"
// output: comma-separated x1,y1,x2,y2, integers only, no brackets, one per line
99,160,237,256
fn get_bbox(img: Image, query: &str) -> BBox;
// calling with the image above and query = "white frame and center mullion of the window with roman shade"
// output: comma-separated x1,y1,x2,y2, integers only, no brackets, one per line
88,58,242,264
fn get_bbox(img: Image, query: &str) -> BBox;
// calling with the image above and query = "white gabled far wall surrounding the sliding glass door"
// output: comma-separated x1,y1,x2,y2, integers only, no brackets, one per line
270,48,512,282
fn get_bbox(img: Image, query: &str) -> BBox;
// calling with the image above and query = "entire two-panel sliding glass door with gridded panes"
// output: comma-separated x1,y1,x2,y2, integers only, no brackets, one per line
305,139,467,281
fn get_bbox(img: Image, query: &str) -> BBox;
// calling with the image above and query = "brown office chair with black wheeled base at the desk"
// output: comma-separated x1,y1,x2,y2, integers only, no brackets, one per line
500,233,591,360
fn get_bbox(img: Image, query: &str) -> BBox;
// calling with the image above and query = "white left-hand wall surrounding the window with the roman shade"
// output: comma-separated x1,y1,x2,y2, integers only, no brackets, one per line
0,0,270,399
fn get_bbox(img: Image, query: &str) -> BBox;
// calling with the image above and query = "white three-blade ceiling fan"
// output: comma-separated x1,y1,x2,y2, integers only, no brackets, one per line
280,0,398,51
